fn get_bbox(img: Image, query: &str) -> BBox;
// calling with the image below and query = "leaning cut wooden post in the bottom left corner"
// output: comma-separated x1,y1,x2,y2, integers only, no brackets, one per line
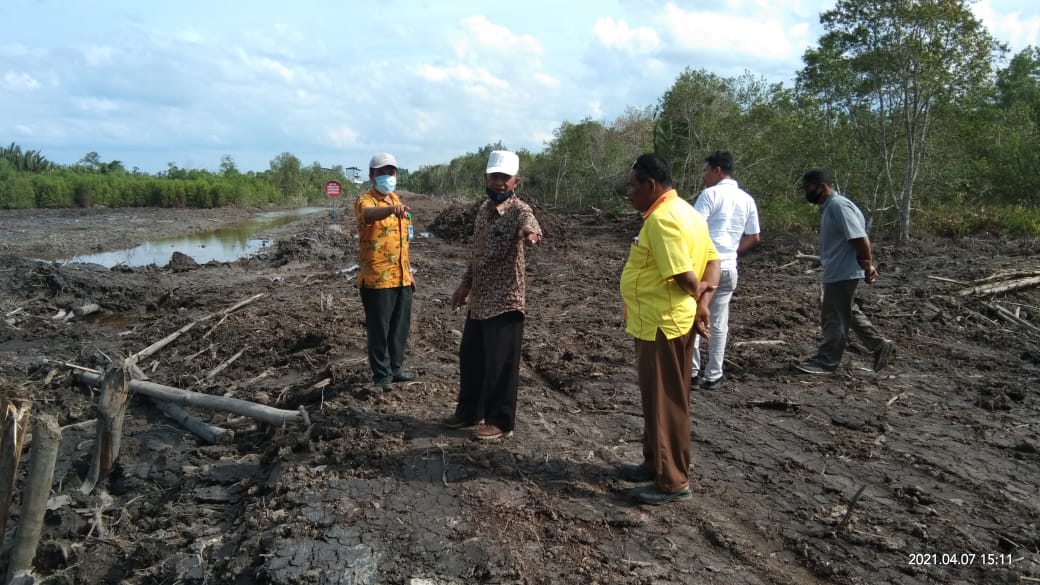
7,414,61,581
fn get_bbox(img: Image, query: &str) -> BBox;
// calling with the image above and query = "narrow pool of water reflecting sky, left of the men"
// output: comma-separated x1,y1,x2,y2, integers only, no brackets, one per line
61,207,329,269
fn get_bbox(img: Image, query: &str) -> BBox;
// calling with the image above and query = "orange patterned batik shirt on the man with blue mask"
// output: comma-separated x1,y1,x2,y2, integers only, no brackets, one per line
354,188,414,288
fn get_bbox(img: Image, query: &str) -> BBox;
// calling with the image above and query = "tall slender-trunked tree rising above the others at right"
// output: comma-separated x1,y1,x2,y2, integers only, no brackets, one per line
798,0,1003,240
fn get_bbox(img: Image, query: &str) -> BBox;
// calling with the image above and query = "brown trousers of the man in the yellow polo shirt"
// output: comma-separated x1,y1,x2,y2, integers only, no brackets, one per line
635,328,697,493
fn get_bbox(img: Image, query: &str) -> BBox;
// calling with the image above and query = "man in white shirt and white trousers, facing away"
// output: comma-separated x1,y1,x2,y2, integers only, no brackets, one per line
692,150,759,390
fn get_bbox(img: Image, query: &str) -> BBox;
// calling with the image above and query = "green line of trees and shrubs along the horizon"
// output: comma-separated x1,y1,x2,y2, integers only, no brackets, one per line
0,0,1040,240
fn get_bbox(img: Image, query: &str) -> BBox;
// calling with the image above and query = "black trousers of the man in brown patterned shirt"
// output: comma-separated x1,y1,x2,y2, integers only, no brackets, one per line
456,311,523,432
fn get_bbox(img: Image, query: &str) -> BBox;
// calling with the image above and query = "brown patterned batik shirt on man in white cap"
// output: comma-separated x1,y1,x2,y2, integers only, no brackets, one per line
462,196,542,319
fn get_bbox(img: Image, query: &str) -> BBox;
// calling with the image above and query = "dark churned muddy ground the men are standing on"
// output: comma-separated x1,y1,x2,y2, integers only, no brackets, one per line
0,196,1040,585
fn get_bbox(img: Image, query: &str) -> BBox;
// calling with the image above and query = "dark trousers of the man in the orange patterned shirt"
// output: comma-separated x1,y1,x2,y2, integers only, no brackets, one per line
361,285,414,384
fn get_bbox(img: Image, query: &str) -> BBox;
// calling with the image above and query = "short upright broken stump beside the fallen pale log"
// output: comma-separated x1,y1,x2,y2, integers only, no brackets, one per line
79,360,131,493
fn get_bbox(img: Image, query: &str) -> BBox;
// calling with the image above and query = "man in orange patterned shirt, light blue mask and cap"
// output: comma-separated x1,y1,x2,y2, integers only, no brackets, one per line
354,152,416,390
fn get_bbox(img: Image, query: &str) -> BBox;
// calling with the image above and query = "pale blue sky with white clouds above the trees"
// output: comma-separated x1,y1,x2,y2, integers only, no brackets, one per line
0,0,1040,173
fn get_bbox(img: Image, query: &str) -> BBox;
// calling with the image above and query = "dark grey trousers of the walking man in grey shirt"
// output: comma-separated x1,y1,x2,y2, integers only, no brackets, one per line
814,279,885,367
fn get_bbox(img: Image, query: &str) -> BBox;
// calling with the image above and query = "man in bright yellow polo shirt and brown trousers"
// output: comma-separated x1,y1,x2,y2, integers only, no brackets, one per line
620,153,720,505
